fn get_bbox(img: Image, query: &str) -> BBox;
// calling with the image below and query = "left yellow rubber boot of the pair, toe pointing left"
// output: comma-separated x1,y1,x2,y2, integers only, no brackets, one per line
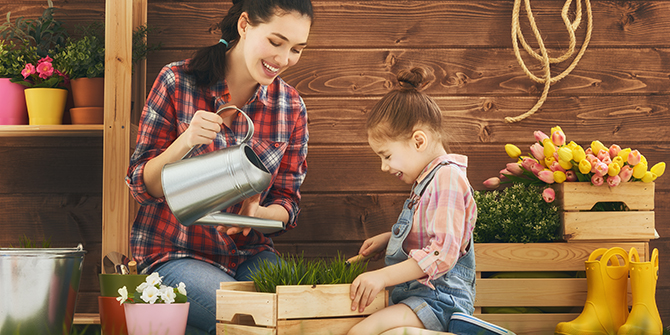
555,247,628,335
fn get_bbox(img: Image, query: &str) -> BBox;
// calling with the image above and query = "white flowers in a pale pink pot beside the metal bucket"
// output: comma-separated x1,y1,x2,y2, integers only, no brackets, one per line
116,272,189,335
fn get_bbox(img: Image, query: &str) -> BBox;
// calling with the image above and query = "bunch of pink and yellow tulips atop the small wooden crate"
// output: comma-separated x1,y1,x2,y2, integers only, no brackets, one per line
484,126,665,200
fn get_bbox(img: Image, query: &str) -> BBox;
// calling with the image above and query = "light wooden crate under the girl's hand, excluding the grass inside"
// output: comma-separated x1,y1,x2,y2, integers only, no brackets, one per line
216,282,388,335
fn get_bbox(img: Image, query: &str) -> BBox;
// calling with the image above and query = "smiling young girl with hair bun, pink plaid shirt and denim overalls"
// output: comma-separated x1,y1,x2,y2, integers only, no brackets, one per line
349,68,506,335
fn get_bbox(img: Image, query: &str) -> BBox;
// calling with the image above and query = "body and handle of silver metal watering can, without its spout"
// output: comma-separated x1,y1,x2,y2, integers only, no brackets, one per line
161,106,272,226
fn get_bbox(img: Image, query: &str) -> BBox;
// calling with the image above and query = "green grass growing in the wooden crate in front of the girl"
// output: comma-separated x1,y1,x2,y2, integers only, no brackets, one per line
251,254,368,293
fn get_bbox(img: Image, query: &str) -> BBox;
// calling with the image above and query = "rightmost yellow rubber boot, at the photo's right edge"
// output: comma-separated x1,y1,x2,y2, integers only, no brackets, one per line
618,248,663,335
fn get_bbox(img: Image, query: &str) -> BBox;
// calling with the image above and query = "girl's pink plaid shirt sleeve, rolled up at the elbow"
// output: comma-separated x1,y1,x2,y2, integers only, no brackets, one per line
409,165,476,288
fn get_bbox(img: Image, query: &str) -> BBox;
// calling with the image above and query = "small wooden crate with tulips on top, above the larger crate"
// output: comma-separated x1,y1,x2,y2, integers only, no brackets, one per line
554,182,658,242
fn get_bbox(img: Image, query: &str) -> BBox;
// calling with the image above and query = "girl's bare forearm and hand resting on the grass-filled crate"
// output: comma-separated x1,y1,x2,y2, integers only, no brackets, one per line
351,258,426,313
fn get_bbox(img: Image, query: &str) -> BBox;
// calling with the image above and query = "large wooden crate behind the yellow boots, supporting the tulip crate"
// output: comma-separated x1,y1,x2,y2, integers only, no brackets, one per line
475,242,649,335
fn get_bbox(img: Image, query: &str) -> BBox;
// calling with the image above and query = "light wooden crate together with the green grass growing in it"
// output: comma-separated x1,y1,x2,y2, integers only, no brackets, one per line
216,256,388,335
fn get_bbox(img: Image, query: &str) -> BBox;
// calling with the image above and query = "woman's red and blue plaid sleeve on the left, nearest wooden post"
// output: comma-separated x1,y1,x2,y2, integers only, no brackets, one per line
126,66,177,205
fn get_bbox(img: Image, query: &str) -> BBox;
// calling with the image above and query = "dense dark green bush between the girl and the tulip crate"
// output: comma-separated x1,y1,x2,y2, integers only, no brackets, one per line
474,184,560,243
